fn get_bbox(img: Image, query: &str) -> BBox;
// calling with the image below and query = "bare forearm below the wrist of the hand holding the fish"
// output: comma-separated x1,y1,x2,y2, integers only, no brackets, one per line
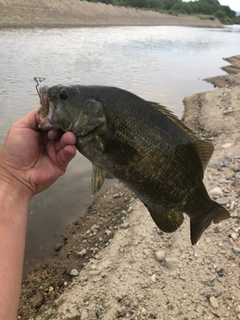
0,179,30,320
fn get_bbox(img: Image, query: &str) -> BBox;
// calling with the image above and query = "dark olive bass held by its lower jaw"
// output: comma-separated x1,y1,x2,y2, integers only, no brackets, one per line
38,84,230,245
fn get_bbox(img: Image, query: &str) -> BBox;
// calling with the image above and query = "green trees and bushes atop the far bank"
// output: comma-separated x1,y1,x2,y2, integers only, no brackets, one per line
88,0,240,24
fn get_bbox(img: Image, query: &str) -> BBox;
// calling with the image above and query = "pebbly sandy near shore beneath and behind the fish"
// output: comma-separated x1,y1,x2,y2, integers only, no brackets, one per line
18,56,240,320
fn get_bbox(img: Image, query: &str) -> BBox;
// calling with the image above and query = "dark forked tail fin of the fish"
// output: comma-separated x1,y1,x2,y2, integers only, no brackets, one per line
190,201,230,245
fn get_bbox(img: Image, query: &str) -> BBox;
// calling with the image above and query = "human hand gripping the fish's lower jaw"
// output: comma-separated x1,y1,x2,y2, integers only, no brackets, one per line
0,111,76,198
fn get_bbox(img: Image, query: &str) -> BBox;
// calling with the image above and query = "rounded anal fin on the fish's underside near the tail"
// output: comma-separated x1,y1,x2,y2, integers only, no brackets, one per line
146,205,184,233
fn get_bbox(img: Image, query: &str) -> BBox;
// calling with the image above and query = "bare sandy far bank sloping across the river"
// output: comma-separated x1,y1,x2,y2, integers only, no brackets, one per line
0,0,222,28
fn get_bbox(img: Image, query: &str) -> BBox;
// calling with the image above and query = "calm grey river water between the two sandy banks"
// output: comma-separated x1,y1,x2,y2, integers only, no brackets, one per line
0,26,240,270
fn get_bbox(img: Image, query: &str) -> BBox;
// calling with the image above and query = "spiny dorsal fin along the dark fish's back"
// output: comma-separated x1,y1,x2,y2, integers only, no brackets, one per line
148,101,214,170
